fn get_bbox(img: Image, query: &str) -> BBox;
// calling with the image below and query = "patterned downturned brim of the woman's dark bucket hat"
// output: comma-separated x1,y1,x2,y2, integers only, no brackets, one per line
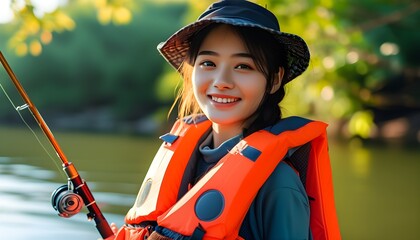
157,18,310,83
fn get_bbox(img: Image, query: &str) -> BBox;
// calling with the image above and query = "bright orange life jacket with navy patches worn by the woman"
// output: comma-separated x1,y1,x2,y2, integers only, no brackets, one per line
116,117,341,240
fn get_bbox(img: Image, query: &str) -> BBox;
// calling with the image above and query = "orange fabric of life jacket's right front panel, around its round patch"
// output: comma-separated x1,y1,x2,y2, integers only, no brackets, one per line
158,131,287,239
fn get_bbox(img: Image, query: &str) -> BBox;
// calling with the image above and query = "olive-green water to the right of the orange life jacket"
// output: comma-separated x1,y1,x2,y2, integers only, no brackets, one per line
330,144,420,240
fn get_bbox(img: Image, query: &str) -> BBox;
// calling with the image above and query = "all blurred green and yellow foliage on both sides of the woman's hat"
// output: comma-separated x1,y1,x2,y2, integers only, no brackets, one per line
0,0,420,138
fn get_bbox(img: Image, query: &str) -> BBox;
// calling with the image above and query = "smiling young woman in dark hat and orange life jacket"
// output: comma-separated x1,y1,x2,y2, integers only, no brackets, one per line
114,0,340,239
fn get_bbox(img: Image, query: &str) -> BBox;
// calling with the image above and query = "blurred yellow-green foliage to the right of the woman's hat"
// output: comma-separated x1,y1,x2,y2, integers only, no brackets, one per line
258,0,420,141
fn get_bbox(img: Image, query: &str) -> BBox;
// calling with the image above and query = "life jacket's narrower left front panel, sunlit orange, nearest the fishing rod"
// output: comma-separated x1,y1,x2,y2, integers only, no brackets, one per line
125,121,211,224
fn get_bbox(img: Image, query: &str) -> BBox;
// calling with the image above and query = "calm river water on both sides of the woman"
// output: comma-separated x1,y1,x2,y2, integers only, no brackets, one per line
0,128,420,240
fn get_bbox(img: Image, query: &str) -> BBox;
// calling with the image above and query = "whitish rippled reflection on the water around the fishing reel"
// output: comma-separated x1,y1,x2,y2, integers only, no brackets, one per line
0,157,128,240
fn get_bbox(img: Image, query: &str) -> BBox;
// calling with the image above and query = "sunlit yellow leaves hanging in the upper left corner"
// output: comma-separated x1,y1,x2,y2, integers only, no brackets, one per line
5,0,138,56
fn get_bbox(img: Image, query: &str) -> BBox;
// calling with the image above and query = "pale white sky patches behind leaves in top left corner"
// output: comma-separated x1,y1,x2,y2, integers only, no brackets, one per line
0,0,67,24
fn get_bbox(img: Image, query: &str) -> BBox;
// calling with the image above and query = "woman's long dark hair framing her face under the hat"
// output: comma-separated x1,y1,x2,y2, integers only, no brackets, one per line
177,23,288,137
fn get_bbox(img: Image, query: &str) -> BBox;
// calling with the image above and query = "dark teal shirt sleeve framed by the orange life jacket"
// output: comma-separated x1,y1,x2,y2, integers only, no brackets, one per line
240,162,310,239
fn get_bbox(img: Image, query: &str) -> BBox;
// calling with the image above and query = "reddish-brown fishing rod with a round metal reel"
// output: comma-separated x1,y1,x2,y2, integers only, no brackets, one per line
0,51,114,239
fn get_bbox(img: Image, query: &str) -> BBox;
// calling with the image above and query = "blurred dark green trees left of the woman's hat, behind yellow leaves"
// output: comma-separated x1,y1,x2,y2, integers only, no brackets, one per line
0,1,186,127
